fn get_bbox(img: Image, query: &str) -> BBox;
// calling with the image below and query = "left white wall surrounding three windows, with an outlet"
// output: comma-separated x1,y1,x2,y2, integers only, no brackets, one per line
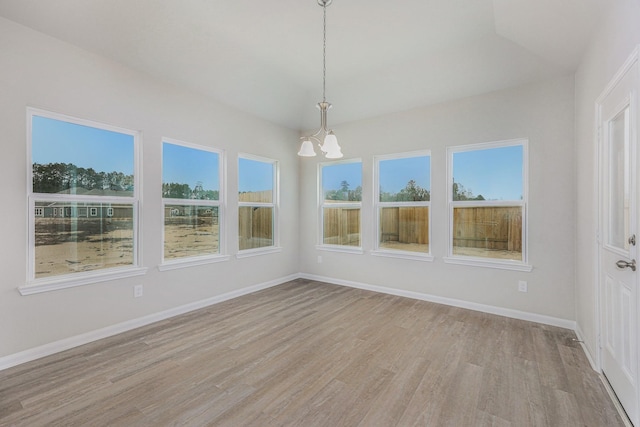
0,18,298,358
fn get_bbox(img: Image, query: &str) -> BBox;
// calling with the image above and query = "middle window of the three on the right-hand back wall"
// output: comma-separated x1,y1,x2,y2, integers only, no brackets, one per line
374,151,432,259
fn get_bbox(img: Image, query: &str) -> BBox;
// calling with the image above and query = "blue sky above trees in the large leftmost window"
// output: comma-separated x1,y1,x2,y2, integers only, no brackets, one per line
31,116,134,175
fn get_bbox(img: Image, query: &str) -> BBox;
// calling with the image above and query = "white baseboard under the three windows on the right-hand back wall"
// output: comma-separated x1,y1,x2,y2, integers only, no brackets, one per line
299,273,576,331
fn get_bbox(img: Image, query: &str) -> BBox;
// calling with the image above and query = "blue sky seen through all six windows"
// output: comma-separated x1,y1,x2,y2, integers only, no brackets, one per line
32,115,523,200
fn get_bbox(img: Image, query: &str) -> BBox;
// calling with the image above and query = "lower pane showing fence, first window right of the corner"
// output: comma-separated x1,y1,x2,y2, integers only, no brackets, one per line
322,208,360,246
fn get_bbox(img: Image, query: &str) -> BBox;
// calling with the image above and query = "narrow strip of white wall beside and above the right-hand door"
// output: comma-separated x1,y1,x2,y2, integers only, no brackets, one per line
575,0,640,360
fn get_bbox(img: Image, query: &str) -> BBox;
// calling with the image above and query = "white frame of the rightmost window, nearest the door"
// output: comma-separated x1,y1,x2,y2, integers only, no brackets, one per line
443,138,533,272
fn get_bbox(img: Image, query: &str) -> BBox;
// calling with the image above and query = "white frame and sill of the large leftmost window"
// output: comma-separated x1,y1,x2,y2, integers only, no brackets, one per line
18,107,147,295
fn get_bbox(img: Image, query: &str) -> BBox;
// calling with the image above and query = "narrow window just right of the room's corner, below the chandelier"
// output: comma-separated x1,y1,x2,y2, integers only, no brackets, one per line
320,160,362,252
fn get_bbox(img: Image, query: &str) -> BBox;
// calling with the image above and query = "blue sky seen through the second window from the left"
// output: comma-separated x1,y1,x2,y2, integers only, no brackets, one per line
162,142,220,190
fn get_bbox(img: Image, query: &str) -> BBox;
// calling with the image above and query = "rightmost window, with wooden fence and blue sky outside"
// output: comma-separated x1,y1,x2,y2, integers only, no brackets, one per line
445,139,531,271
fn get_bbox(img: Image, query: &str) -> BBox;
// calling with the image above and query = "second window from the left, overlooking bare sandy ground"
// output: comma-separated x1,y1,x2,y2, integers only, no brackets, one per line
162,138,223,265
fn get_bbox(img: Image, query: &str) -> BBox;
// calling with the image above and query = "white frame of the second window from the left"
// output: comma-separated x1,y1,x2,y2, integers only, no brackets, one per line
158,137,229,271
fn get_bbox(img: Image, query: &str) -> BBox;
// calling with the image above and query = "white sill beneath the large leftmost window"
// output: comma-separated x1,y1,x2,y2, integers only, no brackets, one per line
18,267,147,295
